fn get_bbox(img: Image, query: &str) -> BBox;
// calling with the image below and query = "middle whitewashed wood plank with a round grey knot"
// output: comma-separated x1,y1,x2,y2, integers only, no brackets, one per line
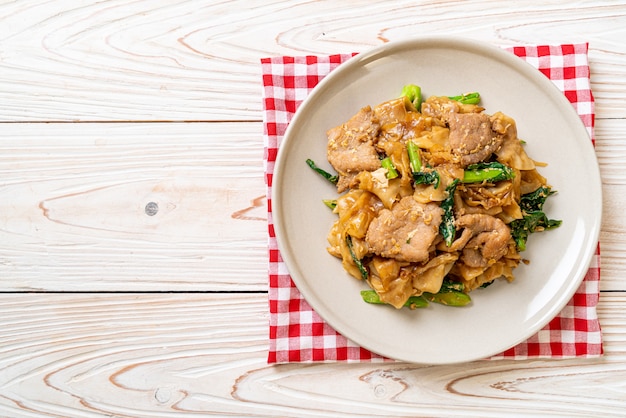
0,119,626,291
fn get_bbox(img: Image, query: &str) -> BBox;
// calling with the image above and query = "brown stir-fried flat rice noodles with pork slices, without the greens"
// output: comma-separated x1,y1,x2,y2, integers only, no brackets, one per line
327,97,546,308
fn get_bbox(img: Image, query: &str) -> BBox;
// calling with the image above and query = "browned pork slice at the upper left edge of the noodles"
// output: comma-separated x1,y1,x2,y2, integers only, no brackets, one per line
326,106,380,192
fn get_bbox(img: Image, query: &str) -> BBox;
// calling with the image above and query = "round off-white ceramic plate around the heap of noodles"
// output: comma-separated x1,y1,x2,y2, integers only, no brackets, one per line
272,38,602,364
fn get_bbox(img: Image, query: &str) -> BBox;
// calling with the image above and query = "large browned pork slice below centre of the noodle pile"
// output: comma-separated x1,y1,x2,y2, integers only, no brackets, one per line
365,196,443,263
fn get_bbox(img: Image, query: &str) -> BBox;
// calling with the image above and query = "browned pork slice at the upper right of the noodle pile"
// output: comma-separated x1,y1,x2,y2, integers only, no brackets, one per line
448,113,502,166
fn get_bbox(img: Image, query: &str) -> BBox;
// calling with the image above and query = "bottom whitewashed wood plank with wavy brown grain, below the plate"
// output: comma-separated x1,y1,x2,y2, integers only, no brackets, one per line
0,293,626,418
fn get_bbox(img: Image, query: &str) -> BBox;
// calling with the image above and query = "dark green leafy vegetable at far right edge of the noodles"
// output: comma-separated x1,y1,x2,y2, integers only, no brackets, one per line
510,187,562,251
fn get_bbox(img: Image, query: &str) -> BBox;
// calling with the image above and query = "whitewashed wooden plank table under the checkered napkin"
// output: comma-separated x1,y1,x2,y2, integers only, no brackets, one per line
0,0,626,418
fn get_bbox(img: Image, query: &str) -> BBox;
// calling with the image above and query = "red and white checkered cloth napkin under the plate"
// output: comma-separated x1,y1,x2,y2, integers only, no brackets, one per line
261,44,603,363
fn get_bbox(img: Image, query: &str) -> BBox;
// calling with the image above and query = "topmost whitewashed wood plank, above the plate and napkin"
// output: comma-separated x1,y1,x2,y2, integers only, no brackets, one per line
0,0,626,121
